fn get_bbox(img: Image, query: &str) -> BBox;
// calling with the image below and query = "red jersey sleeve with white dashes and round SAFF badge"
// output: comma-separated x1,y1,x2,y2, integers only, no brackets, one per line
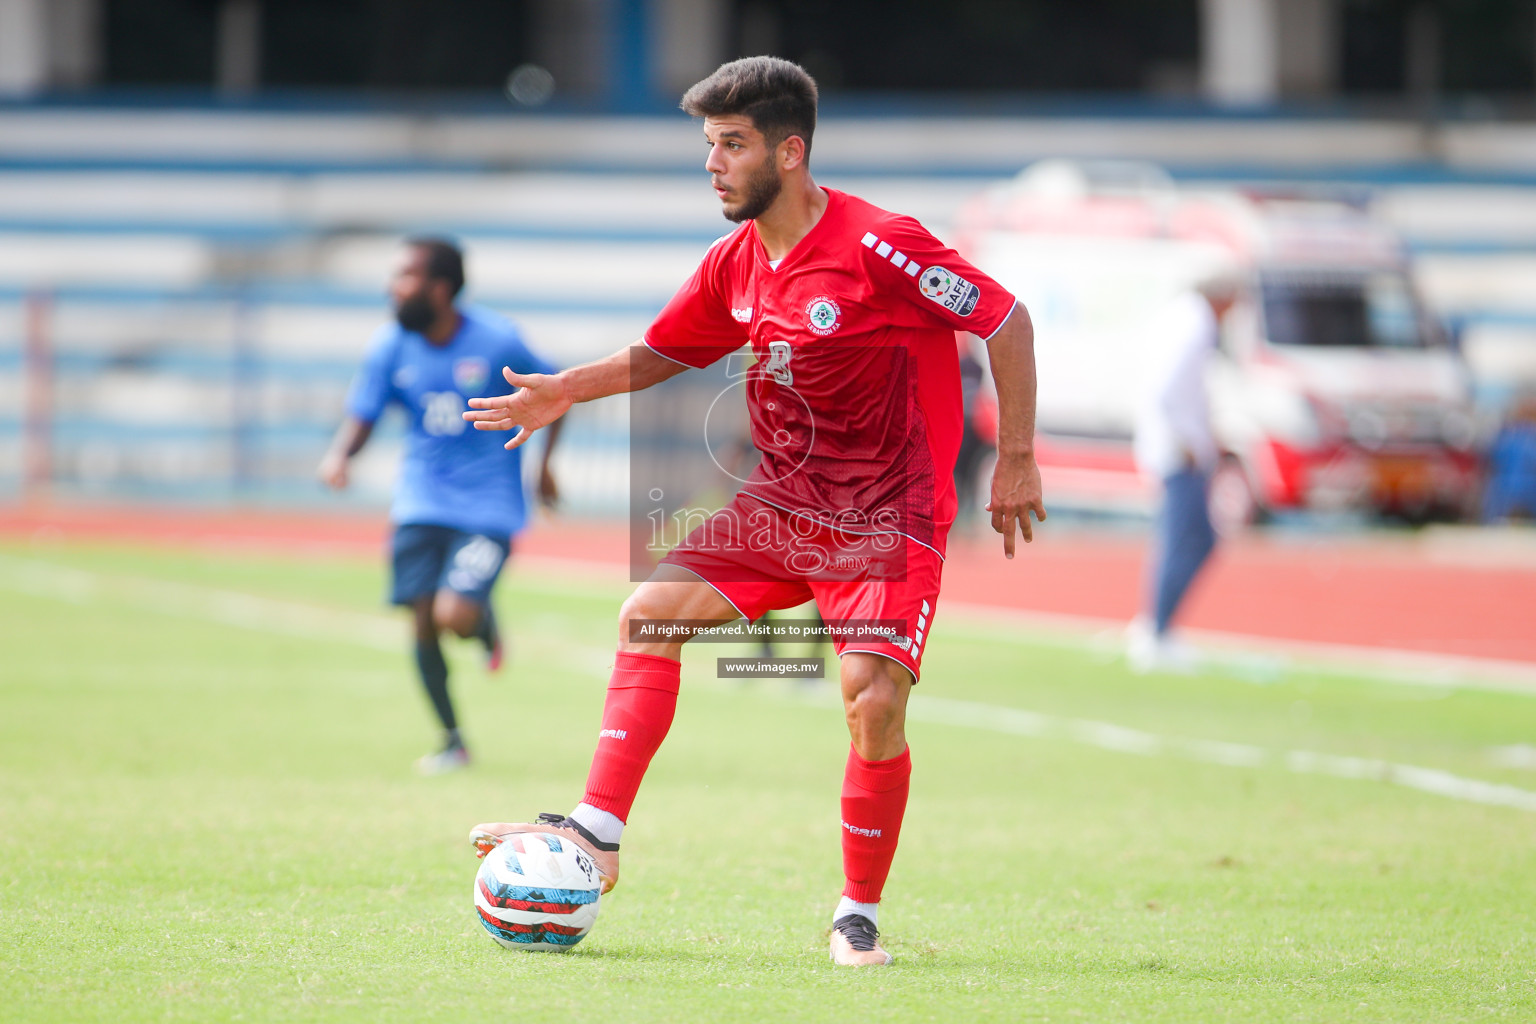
862,216,1018,338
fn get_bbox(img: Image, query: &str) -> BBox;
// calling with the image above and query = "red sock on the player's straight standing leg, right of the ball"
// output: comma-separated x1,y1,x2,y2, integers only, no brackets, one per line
843,745,912,903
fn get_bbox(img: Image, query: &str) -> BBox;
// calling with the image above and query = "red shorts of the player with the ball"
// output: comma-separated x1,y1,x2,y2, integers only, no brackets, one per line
662,494,943,682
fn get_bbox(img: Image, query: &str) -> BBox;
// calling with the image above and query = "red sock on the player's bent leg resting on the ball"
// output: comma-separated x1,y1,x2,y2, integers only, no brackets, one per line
582,651,682,821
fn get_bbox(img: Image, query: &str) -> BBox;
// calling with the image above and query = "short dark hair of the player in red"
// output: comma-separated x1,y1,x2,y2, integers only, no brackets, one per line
679,57,816,157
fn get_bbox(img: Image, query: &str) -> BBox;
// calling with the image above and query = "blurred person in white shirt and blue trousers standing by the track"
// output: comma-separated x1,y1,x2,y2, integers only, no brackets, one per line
1126,270,1238,672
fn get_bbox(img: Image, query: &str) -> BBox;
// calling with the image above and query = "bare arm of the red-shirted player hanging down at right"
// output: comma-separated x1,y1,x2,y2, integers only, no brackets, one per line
986,302,1046,557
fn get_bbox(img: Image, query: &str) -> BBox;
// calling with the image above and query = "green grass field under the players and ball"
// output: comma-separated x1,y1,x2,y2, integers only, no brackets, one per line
0,542,1536,1022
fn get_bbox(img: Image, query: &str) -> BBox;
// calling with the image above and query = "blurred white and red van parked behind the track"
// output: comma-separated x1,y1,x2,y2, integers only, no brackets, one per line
957,160,1478,527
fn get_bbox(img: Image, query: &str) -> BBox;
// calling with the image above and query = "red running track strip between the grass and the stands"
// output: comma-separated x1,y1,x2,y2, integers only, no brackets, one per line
0,505,1536,663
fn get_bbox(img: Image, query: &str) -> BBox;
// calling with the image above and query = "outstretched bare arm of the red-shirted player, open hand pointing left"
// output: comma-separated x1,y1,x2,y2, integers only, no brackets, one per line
464,344,688,448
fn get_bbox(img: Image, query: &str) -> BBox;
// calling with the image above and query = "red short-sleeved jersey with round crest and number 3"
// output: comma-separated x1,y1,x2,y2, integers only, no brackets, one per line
645,189,1015,553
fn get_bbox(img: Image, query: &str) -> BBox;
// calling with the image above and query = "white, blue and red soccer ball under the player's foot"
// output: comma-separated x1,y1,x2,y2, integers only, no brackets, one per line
475,832,602,950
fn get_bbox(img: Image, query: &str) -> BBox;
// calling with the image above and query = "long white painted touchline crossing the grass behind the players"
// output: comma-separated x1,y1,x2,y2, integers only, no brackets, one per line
9,556,1536,812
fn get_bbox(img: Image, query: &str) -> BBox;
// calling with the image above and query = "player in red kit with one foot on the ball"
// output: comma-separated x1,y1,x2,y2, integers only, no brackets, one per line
465,57,1044,966
